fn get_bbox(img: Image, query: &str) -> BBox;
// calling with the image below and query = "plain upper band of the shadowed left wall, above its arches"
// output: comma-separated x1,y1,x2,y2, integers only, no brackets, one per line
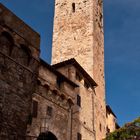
0,4,40,49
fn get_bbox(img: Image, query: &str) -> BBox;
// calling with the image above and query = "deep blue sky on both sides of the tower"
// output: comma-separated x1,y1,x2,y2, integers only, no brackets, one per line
0,0,140,125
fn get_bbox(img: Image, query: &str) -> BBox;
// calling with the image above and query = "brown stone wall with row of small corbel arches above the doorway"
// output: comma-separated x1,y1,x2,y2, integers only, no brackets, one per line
27,64,75,140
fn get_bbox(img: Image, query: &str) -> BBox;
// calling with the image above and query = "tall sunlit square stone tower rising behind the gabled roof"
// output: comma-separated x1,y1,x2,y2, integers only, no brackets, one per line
52,0,106,140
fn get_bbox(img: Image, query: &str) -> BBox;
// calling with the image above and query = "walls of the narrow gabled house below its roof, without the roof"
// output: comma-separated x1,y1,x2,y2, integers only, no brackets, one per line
52,64,95,140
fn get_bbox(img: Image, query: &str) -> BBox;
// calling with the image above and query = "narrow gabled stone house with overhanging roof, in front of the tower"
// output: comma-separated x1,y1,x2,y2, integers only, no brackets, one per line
53,59,97,140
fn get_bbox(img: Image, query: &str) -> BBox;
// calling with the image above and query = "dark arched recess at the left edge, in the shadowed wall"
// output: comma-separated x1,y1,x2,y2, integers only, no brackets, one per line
0,32,14,55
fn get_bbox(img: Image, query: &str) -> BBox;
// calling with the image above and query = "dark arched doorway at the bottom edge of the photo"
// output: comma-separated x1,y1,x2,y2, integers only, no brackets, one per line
37,131,58,140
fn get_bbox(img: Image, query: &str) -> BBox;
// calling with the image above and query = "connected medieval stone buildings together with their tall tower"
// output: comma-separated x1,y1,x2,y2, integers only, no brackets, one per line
0,0,118,140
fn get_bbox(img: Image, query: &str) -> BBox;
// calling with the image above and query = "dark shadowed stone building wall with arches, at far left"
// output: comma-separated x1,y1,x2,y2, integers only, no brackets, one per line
0,4,39,139
